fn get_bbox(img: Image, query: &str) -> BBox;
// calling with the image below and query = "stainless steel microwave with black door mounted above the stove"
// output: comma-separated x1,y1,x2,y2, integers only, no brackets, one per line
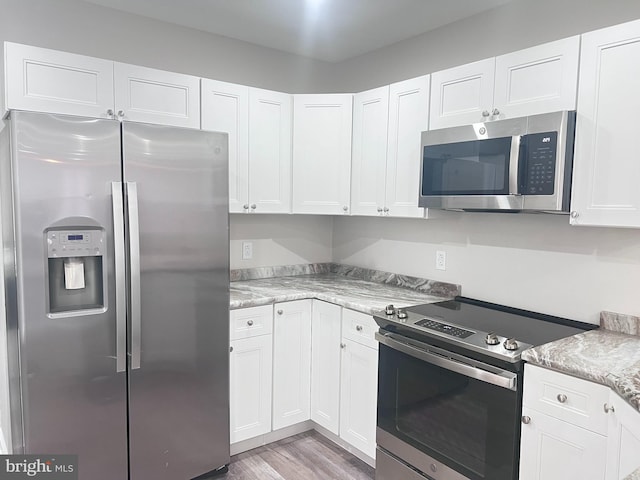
419,111,576,213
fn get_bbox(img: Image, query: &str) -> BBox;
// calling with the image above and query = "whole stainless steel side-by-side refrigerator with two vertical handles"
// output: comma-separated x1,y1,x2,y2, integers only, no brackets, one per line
0,111,229,480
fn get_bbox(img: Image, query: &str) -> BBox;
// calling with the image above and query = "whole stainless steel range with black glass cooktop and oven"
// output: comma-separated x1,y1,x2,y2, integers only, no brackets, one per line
374,297,596,480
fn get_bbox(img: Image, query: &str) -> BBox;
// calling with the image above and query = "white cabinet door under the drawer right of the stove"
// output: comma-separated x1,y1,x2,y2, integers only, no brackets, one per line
520,407,607,480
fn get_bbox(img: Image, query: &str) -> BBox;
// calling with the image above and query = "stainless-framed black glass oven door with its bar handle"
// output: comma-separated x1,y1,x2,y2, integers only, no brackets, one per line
376,333,521,480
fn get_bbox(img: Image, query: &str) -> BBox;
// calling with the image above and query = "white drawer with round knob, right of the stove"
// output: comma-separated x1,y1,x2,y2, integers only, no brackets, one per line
522,364,609,435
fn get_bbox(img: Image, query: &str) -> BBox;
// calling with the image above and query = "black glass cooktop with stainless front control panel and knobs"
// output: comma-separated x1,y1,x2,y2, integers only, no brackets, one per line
374,297,598,363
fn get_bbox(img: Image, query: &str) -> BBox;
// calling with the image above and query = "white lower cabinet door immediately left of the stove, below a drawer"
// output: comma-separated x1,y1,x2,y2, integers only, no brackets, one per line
340,339,378,458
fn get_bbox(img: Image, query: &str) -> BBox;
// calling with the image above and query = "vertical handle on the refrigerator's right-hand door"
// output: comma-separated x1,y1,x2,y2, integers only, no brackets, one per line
126,182,142,370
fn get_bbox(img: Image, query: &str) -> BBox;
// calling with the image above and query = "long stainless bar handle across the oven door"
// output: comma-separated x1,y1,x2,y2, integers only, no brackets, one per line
376,332,518,391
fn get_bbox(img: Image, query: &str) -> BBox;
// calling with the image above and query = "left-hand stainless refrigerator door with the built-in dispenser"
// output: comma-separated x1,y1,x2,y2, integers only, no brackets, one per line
3,112,127,480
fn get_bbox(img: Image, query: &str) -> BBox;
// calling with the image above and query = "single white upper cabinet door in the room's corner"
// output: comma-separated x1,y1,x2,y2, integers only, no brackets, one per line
293,94,353,215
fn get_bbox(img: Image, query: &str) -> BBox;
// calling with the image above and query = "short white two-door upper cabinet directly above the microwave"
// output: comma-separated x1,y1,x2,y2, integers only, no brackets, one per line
430,36,580,129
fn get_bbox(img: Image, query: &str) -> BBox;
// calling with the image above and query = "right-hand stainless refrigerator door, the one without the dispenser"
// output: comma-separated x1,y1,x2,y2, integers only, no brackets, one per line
122,122,229,480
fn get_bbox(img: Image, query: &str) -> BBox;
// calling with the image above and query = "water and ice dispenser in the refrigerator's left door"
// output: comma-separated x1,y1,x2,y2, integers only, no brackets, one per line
45,228,106,314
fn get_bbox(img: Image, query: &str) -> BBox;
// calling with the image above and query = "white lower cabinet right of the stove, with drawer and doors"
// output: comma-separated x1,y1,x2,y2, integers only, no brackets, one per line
520,364,640,480
